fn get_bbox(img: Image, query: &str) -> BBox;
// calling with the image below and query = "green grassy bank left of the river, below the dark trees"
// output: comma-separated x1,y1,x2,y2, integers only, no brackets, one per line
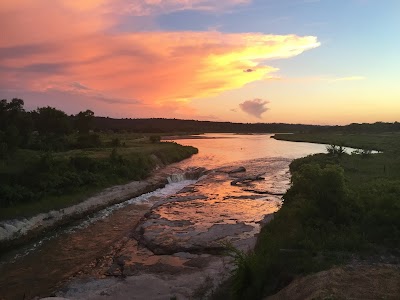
0,133,197,220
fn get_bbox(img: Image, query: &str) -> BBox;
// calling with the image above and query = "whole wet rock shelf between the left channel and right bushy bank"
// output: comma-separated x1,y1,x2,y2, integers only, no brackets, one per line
58,160,288,299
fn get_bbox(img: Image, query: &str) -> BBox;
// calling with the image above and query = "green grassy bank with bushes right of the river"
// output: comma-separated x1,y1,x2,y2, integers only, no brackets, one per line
230,134,400,299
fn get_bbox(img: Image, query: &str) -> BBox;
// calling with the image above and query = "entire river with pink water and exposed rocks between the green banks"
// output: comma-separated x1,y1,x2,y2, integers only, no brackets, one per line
0,134,332,300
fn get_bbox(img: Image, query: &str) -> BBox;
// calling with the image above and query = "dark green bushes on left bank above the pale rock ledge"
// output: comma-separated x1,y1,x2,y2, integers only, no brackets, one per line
0,143,195,219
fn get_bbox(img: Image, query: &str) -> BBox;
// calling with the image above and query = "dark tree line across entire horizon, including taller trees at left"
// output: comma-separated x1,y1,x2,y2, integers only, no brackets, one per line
0,98,400,158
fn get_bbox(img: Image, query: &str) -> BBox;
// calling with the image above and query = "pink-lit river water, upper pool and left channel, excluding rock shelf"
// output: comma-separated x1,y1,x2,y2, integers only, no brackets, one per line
0,134,326,299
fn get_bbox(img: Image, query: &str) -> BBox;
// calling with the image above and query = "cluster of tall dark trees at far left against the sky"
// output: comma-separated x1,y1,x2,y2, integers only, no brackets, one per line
0,98,96,158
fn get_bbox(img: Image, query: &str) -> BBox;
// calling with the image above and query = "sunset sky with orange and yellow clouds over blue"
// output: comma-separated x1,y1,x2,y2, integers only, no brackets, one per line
0,0,400,125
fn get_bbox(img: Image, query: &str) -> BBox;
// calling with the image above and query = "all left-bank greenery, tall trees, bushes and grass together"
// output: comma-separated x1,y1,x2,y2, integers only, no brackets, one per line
0,99,197,219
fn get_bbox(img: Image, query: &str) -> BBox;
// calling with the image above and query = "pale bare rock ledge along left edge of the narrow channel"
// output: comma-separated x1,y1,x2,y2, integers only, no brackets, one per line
0,159,205,256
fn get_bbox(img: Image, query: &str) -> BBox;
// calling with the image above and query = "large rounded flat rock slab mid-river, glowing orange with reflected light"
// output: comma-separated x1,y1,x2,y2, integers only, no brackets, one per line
136,172,280,254
